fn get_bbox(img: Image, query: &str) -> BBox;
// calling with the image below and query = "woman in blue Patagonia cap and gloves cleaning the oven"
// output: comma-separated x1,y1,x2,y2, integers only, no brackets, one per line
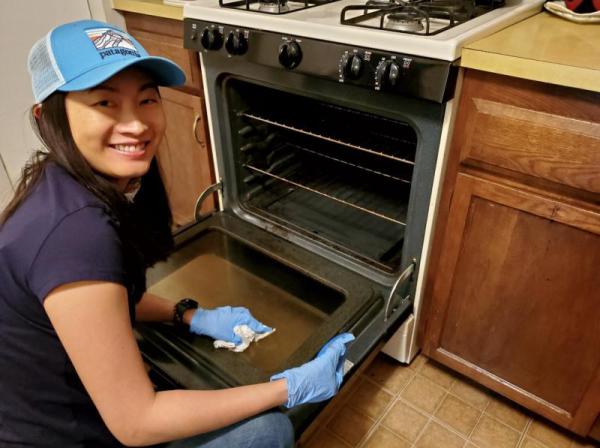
0,21,352,447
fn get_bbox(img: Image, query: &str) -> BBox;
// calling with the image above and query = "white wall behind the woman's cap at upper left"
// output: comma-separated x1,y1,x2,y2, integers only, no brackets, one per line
0,0,124,191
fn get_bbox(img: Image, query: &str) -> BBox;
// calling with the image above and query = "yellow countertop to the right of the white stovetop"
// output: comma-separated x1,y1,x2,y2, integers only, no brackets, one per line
460,11,600,92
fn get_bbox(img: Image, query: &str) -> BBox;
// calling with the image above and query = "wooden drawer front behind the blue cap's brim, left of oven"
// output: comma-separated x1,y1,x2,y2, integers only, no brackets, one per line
124,13,202,96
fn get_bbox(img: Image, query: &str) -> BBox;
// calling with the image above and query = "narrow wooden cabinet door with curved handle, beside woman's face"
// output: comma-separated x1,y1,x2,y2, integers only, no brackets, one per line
157,88,215,227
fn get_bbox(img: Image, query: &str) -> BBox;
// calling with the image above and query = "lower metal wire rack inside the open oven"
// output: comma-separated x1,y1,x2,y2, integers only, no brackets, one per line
243,164,406,226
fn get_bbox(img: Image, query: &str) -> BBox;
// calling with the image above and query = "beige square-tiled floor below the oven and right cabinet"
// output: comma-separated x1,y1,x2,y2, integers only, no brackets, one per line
301,353,600,448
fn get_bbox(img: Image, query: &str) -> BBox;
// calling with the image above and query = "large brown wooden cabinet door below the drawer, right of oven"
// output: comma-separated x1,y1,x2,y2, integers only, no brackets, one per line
423,173,600,435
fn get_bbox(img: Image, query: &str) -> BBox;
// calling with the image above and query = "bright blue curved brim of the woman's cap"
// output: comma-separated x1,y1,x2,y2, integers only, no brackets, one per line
56,56,185,92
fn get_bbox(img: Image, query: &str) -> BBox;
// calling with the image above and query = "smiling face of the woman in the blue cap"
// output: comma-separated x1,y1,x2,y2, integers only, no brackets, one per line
65,68,165,190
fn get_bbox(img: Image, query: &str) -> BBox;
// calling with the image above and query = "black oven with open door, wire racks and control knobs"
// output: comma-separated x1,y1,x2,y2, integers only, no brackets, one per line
136,2,544,433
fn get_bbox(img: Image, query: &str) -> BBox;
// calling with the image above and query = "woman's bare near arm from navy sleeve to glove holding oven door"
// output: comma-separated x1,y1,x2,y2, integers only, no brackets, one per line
44,282,288,446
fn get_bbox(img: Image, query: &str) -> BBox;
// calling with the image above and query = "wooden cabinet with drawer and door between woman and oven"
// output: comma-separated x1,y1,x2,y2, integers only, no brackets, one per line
118,12,215,228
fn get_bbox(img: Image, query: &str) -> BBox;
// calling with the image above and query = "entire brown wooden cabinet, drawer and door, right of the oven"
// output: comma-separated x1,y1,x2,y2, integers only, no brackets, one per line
419,69,600,435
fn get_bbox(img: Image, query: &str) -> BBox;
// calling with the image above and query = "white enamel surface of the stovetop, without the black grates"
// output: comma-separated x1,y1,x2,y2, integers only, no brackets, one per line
183,0,544,61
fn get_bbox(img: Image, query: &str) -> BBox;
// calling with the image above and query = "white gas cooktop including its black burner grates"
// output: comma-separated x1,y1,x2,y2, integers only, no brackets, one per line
184,0,543,61
